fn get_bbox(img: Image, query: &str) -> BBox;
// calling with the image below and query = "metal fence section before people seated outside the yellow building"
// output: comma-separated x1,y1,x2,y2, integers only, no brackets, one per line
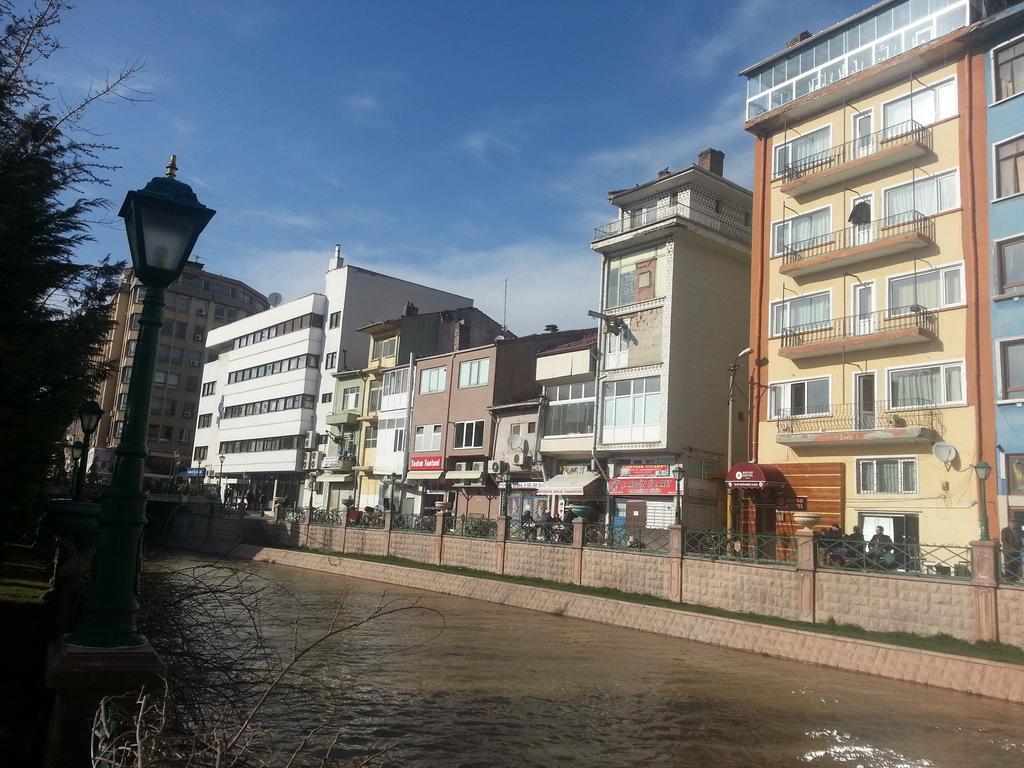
815,539,971,579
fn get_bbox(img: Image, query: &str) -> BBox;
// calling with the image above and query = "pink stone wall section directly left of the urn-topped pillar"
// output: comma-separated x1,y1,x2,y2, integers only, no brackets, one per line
680,557,800,621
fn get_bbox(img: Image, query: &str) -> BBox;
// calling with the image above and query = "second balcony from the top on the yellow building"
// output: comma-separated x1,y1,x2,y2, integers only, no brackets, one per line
778,211,935,278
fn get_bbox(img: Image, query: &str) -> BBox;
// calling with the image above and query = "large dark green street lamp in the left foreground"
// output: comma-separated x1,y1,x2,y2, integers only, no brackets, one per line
67,155,214,648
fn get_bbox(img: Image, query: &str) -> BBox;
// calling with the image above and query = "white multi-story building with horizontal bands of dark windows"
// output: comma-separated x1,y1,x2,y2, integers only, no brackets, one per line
193,248,473,510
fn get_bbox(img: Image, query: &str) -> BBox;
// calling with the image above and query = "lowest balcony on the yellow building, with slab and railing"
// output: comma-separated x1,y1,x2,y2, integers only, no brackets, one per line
775,398,943,447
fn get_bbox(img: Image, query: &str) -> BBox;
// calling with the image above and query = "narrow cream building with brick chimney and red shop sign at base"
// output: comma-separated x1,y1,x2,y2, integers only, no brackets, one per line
593,150,751,527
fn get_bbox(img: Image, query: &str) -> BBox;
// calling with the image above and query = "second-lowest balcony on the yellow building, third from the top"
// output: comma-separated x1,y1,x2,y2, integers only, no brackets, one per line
778,305,939,360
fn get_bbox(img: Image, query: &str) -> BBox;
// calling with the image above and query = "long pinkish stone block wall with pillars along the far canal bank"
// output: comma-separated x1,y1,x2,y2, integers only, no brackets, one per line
165,514,1024,648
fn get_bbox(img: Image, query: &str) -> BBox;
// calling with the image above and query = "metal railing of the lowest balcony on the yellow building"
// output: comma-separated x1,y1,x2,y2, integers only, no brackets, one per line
775,397,943,434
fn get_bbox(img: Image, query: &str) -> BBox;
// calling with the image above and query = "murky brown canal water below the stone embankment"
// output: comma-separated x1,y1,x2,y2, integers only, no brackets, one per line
148,558,1024,768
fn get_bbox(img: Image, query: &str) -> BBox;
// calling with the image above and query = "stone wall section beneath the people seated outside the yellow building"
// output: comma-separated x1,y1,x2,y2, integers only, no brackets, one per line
815,570,978,640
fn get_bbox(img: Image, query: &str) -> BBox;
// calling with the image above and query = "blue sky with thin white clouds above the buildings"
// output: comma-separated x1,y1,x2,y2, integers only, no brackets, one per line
41,0,869,334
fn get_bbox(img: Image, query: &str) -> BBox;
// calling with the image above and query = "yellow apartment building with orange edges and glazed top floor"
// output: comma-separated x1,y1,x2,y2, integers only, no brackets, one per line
728,0,1005,544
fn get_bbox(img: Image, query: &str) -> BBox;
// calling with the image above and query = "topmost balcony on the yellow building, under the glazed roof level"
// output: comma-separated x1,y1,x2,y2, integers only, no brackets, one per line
775,120,932,198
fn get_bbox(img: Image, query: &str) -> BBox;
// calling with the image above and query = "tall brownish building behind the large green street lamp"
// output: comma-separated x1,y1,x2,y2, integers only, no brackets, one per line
90,261,269,477
